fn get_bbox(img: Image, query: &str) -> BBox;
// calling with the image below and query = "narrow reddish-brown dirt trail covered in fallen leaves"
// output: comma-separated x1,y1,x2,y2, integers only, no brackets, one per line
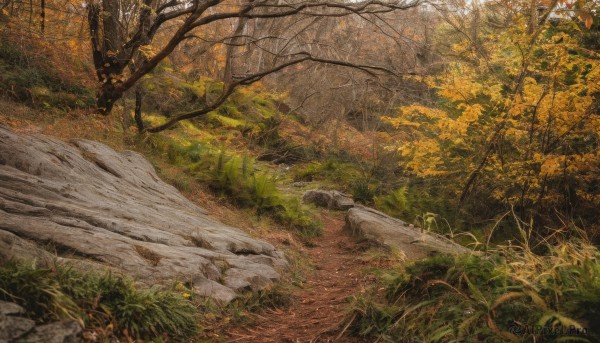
227,212,373,343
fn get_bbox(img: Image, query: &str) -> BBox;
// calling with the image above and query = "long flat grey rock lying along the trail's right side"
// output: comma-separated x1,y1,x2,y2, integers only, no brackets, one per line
345,206,471,259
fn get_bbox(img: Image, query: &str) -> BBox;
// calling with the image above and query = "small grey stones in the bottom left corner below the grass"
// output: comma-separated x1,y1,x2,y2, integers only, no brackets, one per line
0,301,81,343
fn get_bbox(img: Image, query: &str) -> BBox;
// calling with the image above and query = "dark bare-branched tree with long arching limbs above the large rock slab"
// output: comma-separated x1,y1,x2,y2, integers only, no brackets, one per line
87,0,420,132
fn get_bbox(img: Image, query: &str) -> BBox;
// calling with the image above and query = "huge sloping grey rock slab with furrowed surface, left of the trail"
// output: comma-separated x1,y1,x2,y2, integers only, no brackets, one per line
0,127,286,302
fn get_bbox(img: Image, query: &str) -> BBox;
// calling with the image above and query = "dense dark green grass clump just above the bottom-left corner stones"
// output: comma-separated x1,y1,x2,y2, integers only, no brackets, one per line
0,260,197,340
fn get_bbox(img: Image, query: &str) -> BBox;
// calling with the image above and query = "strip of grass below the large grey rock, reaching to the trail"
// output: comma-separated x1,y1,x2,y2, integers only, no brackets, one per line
0,260,292,342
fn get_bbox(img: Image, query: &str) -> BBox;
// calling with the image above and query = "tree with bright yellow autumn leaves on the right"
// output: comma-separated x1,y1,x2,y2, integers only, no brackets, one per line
388,2,600,234
